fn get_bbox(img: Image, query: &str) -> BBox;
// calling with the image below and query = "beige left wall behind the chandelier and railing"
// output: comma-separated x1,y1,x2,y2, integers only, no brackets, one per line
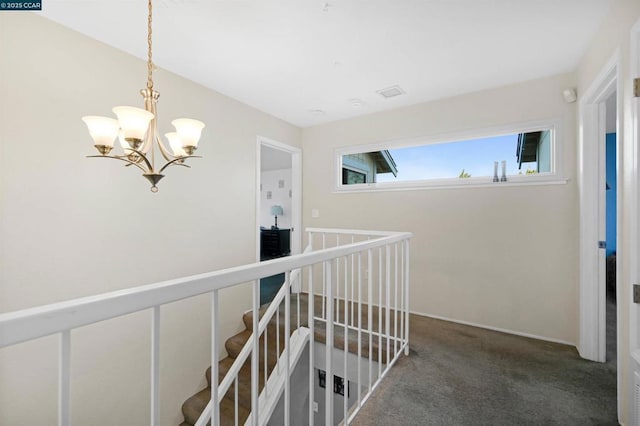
0,12,300,425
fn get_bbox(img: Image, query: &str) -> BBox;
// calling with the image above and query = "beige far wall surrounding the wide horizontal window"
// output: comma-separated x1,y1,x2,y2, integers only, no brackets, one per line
303,74,578,344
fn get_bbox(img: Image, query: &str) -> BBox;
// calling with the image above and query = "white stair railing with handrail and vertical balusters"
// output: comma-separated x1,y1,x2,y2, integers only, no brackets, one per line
0,229,411,426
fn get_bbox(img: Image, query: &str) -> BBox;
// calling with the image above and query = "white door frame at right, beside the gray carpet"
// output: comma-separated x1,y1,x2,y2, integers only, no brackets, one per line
578,50,624,414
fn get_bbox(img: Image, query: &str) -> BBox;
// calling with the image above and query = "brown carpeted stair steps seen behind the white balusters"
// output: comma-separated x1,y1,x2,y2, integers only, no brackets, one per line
180,293,395,426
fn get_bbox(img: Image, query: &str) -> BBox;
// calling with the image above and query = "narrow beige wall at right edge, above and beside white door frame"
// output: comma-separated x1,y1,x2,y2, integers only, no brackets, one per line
576,0,640,424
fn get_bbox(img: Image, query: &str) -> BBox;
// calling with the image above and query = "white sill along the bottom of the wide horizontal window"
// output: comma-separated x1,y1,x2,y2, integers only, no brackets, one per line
333,176,569,193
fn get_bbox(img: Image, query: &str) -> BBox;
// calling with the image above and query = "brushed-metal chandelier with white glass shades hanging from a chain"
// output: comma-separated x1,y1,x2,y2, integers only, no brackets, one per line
82,0,204,192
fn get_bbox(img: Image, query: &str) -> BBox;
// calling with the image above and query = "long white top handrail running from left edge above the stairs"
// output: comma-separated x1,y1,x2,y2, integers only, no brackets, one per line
0,230,412,348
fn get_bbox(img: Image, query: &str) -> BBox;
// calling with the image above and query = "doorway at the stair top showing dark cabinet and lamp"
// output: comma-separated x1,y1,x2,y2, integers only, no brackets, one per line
256,137,302,305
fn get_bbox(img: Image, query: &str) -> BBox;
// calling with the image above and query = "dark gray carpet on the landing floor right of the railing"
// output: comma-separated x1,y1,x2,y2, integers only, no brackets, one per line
353,315,618,426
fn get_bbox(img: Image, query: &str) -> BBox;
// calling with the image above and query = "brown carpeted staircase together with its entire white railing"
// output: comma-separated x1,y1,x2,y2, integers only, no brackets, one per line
0,228,412,426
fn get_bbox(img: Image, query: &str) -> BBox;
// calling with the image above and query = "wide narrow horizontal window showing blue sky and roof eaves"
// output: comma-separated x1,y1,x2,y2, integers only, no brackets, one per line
337,124,561,190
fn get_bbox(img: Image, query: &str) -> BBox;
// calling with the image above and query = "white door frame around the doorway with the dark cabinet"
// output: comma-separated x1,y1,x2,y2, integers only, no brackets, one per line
255,136,302,262
